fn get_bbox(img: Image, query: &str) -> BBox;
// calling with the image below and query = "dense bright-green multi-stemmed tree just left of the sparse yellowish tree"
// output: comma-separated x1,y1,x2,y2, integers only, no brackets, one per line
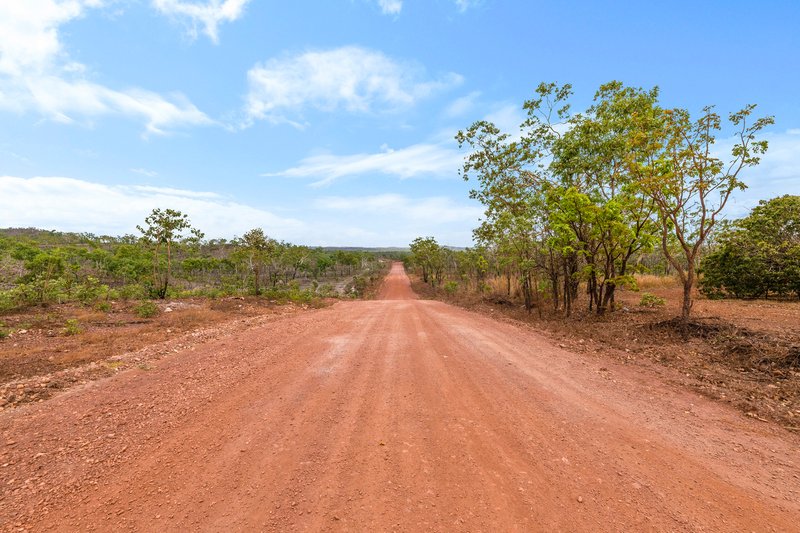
549,81,661,313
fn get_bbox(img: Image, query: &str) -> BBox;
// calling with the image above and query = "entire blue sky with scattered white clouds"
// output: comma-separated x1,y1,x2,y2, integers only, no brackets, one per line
0,0,800,246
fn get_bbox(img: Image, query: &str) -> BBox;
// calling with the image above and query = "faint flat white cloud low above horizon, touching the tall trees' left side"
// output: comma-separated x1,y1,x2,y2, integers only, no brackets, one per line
314,194,483,224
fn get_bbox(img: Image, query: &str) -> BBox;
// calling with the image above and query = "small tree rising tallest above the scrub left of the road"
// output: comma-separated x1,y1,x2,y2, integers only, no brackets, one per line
136,208,203,299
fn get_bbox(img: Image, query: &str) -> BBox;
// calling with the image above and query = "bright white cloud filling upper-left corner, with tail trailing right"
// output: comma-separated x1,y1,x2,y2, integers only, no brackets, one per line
0,0,212,134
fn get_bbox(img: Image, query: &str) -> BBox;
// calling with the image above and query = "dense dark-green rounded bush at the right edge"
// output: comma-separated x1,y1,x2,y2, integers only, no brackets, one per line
700,195,800,298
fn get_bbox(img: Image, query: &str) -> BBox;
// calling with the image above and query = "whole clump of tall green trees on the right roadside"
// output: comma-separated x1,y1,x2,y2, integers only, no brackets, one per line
454,81,773,319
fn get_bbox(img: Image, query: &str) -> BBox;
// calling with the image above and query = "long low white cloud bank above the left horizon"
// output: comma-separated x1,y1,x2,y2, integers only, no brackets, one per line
0,176,305,238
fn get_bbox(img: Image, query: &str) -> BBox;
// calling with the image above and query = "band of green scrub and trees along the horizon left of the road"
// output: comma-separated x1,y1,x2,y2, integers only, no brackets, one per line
0,209,402,311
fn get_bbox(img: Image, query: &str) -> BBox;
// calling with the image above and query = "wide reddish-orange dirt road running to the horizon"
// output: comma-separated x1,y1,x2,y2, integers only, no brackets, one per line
0,264,800,531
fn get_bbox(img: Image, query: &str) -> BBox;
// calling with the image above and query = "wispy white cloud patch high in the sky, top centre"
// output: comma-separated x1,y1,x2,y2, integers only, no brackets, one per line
245,46,462,122
